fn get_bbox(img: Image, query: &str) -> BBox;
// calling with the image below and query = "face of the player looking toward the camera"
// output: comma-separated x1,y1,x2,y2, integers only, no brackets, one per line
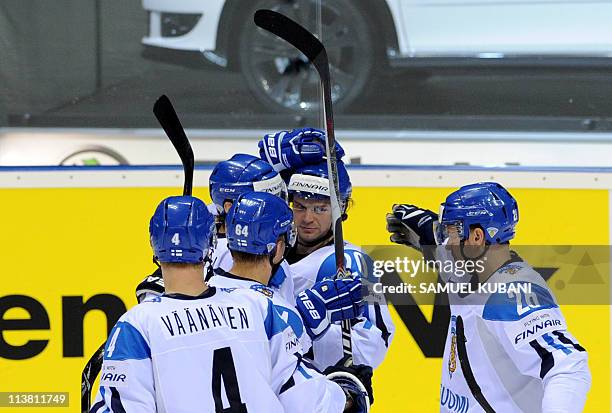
293,197,332,242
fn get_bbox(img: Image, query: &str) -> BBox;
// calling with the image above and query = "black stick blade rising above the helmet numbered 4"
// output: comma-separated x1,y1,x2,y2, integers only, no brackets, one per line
153,95,195,195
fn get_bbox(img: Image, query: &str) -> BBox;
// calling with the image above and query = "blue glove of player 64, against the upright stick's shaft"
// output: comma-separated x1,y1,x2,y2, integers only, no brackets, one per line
296,278,363,340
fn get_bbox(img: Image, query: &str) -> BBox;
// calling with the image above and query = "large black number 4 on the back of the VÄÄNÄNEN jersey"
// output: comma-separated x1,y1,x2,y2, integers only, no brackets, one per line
212,347,248,413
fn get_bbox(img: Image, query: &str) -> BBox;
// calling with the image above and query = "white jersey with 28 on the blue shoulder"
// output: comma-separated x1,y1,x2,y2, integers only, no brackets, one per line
440,257,591,413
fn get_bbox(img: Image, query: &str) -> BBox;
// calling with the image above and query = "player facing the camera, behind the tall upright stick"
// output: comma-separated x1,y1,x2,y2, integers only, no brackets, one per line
259,128,394,369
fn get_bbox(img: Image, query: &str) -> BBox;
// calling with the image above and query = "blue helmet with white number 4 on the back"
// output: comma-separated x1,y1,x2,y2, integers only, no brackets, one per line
149,196,215,264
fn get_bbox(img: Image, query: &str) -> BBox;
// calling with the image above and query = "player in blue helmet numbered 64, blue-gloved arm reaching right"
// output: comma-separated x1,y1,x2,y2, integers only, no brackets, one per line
208,192,363,354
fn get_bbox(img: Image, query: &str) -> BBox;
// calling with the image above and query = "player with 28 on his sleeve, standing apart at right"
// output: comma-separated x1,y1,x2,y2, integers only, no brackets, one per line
387,182,591,413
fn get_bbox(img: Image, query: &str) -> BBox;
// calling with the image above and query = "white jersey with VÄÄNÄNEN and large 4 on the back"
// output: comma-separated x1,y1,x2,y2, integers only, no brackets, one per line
91,287,346,413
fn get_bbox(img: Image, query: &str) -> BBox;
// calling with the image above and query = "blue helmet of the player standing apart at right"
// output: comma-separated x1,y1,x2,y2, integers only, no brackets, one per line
436,182,518,244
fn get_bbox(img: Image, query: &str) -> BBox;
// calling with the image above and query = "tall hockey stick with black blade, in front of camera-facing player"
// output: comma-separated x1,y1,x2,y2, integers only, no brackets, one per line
254,10,353,364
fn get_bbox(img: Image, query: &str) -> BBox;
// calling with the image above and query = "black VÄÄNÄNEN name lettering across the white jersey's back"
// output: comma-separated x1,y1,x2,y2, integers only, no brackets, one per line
160,304,252,338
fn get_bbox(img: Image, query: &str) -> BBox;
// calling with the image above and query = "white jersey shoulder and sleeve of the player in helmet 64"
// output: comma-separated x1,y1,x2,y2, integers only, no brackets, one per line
208,268,311,355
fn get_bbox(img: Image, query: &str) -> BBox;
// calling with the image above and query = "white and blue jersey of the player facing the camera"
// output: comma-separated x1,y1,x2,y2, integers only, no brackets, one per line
290,242,395,370
